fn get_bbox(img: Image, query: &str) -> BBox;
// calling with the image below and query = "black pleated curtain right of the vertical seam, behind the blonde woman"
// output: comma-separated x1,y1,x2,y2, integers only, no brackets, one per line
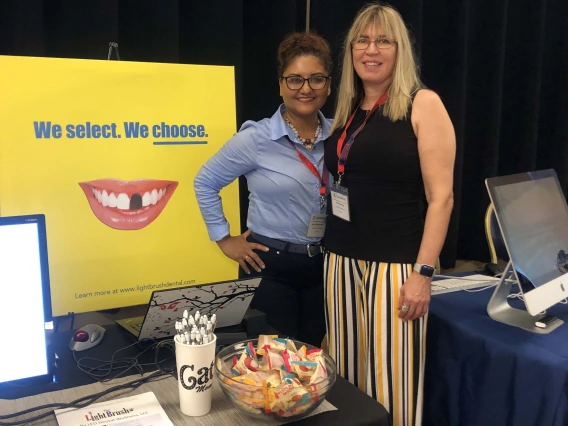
311,0,568,267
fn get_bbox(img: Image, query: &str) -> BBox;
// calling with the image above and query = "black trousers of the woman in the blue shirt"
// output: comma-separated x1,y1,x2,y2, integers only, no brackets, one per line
241,237,326,348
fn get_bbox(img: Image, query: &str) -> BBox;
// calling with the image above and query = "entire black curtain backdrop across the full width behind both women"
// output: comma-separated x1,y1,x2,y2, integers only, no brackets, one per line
0,0,568,267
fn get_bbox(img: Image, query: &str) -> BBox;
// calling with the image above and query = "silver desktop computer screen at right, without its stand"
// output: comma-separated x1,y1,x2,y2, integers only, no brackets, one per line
486,169,568,332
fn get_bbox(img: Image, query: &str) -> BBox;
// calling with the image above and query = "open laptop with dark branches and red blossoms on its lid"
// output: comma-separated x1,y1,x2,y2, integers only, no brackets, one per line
116,277,262,340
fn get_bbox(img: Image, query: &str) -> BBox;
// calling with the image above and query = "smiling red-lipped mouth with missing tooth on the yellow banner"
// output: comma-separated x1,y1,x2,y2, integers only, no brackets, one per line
79,179,178,230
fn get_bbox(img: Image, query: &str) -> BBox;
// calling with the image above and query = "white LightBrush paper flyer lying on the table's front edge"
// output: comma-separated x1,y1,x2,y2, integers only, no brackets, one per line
55,392,173,426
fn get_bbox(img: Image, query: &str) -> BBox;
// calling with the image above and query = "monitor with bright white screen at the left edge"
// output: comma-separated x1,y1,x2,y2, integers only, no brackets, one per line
0,215,53,390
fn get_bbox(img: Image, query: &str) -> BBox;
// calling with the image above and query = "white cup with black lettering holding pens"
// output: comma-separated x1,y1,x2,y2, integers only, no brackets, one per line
174,335,217,416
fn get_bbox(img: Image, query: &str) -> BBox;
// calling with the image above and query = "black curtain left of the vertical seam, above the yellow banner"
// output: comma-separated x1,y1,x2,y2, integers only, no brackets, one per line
0,0,305,238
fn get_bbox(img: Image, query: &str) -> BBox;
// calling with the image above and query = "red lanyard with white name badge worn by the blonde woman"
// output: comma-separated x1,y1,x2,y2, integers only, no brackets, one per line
330,92,387,222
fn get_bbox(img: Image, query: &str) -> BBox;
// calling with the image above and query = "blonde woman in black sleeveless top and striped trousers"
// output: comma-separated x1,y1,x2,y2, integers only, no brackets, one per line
324,4,455,426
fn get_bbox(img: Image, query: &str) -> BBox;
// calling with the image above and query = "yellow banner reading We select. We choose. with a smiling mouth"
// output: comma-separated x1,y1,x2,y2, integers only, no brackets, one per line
0,56,239,315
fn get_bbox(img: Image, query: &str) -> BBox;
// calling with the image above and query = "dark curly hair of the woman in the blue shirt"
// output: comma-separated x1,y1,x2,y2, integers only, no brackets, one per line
278,33,333,77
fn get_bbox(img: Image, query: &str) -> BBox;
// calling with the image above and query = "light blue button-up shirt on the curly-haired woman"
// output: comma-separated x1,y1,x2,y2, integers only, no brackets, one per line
194,104,331,244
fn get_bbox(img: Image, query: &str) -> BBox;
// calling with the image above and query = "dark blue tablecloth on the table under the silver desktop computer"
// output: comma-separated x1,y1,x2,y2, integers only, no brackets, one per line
424,289,568,426
